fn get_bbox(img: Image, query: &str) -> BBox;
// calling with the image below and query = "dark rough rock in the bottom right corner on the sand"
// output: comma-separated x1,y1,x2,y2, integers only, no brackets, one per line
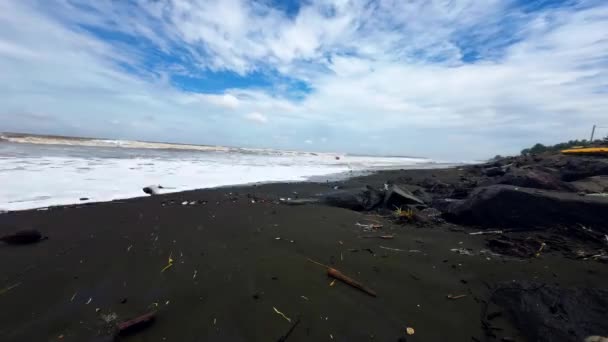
491,282,608,342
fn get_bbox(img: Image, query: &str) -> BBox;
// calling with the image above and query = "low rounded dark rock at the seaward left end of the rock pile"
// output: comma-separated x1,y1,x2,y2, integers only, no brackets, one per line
322,186,384,211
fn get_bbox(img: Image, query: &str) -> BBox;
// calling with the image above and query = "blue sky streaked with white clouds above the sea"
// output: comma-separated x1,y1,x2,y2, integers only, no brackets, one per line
0,0,608,160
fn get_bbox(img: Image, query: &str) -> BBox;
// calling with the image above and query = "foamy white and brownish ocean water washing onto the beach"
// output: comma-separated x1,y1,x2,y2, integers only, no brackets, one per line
0,136,445,211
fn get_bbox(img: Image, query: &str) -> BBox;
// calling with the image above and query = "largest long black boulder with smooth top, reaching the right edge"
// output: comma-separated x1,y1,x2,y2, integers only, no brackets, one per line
444,185,608,231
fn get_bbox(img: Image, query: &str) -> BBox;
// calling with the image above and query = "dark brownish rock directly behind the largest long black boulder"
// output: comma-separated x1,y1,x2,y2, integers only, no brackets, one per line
497,168,574,191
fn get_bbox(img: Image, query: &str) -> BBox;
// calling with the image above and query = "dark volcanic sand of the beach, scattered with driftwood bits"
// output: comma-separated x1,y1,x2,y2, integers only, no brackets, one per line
0,169,608,341
